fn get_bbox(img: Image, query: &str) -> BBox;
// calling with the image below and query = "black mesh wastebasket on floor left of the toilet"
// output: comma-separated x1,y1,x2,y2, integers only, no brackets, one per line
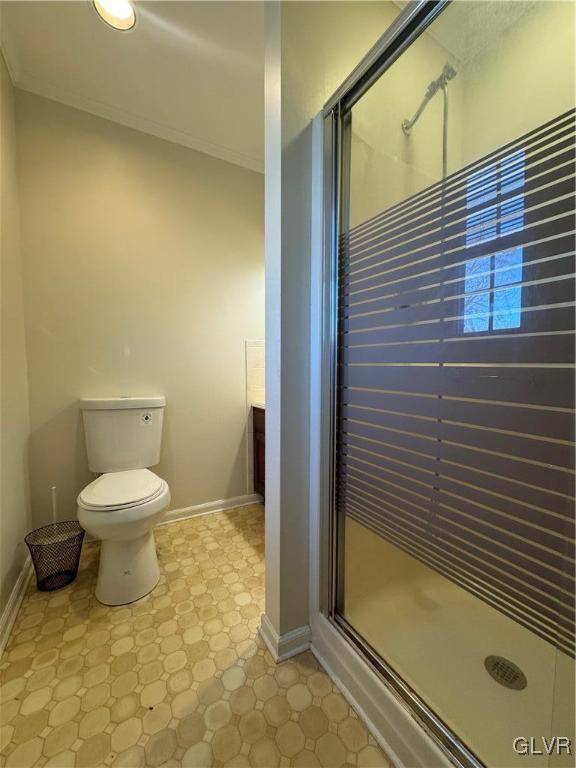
24,520,84,592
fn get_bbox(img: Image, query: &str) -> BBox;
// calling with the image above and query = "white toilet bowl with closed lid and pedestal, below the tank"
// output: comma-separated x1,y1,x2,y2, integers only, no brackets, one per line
77,469,170,605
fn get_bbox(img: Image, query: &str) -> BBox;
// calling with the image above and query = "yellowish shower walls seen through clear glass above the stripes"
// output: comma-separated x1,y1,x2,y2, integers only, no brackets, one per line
350,0,575,226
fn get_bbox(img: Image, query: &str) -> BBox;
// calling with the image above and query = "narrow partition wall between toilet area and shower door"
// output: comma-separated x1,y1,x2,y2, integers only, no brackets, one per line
264,2,399,636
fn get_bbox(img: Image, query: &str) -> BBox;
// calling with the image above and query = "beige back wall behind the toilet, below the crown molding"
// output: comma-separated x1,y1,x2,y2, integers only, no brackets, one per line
17,92,264,523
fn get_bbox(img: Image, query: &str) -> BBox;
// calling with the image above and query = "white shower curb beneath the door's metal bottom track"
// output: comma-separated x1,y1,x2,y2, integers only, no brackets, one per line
311,614,453,768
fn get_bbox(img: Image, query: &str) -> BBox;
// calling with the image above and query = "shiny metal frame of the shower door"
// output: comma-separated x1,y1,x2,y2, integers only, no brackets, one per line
311,0,484,768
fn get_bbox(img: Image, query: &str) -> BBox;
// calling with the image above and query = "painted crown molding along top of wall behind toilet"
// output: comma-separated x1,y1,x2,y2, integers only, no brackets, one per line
14,68,264,173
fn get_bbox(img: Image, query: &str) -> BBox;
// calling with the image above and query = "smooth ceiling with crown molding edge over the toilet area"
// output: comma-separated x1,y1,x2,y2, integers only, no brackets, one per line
2,0,264,171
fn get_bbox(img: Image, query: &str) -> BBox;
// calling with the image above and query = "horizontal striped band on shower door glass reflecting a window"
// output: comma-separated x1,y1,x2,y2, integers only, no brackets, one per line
336,110,575,654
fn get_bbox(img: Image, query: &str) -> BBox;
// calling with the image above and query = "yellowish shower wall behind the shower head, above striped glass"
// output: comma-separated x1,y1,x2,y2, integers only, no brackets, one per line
350,25,462,227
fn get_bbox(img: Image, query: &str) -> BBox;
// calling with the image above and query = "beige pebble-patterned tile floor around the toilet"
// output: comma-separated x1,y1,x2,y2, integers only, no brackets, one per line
0,505,389,768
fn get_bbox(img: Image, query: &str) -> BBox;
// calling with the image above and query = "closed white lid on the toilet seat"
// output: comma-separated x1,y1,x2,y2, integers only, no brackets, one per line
78,469,162,507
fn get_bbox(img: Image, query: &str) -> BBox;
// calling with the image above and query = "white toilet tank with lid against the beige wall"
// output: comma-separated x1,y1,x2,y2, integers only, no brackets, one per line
80,396,166,472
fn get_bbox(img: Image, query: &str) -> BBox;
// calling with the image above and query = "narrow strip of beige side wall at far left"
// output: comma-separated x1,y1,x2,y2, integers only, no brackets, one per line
0,54,29,614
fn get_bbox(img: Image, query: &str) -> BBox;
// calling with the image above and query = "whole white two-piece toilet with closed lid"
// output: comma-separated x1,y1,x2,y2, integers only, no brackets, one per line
78,397,170,605
